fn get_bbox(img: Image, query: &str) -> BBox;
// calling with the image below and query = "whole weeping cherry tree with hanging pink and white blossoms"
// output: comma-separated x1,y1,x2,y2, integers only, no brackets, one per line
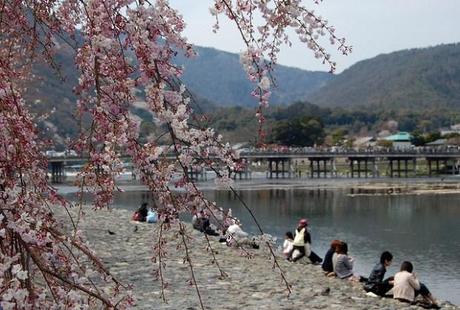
0,0,350,309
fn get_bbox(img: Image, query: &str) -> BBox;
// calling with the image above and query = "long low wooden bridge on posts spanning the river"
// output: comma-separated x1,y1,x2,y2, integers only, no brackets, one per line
48,149,460,183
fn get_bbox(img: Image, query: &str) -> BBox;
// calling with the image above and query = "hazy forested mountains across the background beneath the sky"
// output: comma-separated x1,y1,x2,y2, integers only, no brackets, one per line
26,40,460,147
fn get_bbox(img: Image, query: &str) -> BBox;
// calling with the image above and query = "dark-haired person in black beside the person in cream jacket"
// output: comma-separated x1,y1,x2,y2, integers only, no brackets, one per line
364,251,393,297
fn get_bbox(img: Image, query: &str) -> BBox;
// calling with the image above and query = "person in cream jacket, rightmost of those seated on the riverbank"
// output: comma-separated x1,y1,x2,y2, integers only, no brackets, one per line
393,261,439,308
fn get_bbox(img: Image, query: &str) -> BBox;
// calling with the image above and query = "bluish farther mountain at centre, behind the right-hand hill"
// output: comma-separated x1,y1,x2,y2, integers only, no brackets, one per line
178,47,333,106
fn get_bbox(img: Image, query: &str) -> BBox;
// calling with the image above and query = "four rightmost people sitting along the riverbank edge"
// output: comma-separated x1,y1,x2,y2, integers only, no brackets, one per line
321,240,439,309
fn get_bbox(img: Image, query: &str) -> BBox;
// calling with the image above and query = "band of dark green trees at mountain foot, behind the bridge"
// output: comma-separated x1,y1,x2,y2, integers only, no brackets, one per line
201,102,460,146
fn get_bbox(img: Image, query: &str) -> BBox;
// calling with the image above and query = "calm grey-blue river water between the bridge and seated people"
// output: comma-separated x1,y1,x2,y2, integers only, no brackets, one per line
65,189,460,305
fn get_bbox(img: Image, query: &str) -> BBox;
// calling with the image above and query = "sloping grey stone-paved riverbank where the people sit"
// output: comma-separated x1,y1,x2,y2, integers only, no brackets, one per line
53,207,460,309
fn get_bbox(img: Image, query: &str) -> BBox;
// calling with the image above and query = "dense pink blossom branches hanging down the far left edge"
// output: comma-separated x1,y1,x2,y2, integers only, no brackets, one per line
0,0,132,309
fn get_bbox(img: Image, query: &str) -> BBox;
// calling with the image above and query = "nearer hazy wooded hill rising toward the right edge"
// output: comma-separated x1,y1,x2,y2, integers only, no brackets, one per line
308,43,460,108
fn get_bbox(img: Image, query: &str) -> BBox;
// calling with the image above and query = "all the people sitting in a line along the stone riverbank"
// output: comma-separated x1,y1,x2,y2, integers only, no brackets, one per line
132,207,439,309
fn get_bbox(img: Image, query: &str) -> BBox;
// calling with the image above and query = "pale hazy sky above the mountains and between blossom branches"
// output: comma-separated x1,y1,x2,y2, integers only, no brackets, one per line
171,0,460,72
